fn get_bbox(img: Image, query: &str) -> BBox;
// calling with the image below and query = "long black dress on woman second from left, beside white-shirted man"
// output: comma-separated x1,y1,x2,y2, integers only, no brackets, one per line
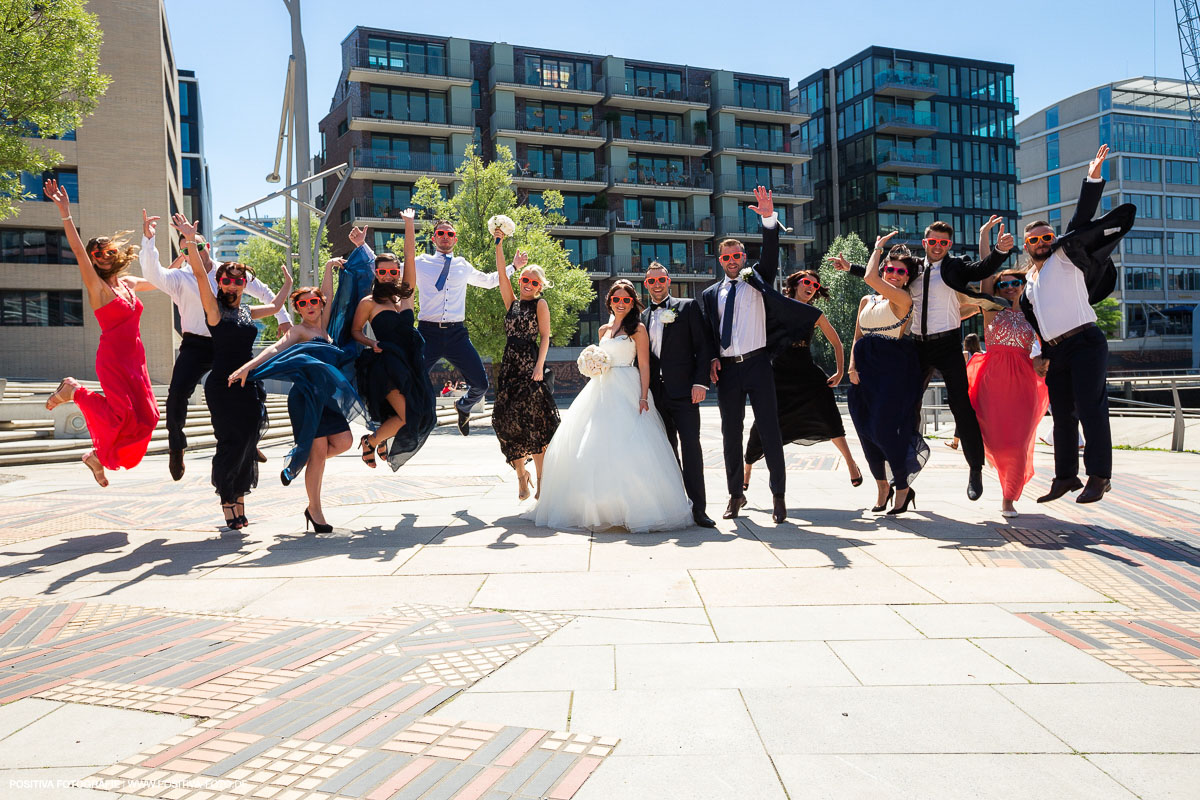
204,303,266,503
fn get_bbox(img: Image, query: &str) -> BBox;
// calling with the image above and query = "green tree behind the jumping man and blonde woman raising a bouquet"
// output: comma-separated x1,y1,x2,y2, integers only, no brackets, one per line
398,145,595,361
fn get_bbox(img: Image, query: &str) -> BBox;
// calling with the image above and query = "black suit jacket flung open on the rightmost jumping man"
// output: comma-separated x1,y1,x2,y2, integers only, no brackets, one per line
1021,179,1138,336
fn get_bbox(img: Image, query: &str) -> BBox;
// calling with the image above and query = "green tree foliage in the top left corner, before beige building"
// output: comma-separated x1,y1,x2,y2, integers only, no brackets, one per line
0,0,109,219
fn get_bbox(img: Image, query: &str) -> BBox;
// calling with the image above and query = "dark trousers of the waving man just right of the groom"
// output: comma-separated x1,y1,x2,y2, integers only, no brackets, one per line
716,353,786,498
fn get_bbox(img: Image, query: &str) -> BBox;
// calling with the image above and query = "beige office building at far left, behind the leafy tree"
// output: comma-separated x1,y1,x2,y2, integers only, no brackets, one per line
0,0,184,383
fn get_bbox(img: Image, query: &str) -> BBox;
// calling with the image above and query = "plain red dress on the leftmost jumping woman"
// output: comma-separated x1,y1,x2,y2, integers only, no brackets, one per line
74,294,158,469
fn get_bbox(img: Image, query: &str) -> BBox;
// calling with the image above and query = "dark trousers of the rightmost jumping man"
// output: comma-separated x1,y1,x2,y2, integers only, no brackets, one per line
1043,327,1112,480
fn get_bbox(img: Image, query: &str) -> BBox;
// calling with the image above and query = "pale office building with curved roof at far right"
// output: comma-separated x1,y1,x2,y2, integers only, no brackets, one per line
1016,77,1200,366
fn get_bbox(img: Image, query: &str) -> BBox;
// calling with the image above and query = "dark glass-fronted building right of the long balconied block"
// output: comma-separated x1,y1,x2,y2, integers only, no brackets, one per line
792,47,1018,266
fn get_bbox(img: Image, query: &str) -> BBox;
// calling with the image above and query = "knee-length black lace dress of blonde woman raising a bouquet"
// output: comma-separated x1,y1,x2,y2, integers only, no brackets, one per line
492,300,559,462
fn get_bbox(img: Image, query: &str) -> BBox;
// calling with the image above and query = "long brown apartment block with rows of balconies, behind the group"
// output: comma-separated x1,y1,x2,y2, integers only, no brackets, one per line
320,28,809,344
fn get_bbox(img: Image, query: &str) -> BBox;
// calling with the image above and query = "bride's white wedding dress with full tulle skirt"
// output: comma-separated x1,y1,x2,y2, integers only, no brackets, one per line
526,336,694,533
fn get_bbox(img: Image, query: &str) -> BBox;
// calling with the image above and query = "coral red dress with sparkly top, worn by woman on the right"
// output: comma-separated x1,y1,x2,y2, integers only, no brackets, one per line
967,309,1050,500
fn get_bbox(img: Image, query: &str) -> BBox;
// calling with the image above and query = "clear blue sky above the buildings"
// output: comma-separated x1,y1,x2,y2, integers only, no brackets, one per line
166,0,1183,218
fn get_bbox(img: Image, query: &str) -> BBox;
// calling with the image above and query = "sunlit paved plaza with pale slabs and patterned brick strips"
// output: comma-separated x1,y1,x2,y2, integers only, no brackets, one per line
0,407,1200,800
